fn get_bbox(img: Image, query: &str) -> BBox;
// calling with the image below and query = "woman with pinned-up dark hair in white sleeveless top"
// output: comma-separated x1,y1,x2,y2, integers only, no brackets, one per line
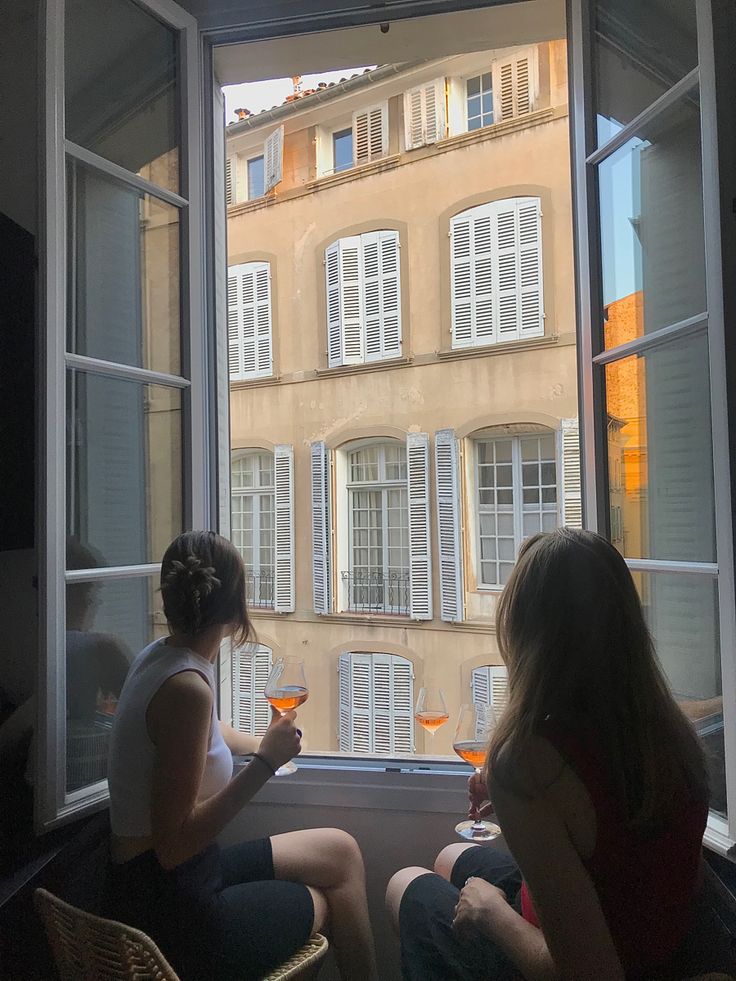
104,531,377,981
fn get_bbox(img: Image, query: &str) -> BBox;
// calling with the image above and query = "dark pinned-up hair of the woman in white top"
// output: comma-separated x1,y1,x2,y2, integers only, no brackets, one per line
161,531,251,645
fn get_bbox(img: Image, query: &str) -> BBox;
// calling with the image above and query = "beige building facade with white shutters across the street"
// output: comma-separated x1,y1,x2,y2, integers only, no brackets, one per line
227,41,580,755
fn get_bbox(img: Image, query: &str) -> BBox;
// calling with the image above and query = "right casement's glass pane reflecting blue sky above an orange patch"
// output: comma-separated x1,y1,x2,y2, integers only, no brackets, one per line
598,92,706,348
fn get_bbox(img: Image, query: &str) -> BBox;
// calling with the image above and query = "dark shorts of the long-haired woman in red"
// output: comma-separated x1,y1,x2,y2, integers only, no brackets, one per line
399,843,521,981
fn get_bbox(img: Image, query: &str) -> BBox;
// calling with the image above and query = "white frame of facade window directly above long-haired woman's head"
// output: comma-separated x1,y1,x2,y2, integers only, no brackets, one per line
472,429,562,592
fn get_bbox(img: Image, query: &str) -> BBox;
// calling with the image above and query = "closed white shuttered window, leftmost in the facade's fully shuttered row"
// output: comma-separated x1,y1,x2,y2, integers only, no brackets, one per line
227,262,273,381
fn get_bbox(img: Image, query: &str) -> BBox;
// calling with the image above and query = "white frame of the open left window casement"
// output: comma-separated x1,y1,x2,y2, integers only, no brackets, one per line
40,0,204,832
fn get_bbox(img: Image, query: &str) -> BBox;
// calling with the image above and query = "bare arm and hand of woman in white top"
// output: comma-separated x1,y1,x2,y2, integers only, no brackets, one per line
146,671,300,869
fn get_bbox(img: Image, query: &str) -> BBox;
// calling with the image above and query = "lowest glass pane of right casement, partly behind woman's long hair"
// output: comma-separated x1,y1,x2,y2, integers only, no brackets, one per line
633,572,726,815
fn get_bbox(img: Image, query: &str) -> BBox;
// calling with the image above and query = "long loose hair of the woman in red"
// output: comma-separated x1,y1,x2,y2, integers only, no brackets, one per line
488,528,708,829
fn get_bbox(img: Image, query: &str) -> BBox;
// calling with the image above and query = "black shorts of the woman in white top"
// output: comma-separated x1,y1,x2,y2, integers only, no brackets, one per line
103,838,314,981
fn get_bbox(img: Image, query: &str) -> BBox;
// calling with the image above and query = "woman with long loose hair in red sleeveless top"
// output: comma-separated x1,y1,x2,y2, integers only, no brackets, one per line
387,528,708,981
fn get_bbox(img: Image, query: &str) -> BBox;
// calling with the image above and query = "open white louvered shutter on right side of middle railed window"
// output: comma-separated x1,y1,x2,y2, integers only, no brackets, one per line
406,433,432,620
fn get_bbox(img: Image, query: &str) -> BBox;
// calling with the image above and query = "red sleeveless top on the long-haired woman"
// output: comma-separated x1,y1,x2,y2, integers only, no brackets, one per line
521,724,708,977
